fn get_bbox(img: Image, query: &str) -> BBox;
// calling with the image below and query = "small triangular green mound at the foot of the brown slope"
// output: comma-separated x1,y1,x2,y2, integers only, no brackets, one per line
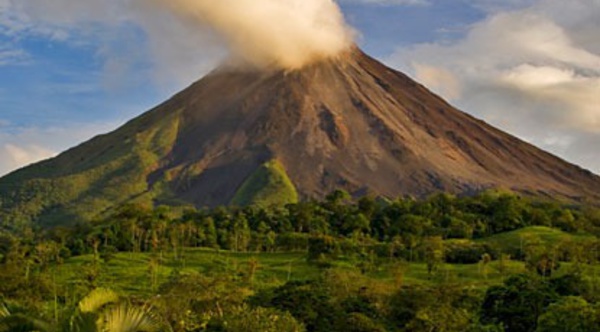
231,160,298,207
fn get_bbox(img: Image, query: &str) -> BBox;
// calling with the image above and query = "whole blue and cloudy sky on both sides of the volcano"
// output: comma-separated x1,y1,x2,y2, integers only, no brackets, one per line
0,0,600,174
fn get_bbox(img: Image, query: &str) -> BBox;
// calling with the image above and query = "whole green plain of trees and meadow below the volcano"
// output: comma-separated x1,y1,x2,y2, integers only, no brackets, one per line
0,192,600,332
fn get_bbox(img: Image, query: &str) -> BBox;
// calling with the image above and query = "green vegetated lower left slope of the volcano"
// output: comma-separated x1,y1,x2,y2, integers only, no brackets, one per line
0,107,180,226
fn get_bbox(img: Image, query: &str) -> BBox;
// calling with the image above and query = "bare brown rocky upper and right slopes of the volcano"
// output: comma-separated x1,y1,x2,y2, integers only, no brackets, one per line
149,48,600,206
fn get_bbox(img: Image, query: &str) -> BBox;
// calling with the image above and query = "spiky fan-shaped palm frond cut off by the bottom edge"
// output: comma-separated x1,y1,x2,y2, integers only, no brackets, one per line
101,304,162,332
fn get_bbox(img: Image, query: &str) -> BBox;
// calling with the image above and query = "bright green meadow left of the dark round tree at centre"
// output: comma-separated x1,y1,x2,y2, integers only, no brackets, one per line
57,248,319,294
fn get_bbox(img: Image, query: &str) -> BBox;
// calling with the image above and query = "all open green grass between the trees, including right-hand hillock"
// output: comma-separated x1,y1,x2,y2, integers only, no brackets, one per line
49,227,600,295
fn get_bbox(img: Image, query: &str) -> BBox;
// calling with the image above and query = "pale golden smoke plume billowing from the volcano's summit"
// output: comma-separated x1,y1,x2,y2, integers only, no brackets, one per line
147,0,353,69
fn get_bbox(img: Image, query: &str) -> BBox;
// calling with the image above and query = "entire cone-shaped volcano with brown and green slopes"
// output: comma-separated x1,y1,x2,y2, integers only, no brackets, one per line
0,47,600,224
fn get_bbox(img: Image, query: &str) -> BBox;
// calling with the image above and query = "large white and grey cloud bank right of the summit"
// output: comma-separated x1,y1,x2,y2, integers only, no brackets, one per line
388,0,600,173
